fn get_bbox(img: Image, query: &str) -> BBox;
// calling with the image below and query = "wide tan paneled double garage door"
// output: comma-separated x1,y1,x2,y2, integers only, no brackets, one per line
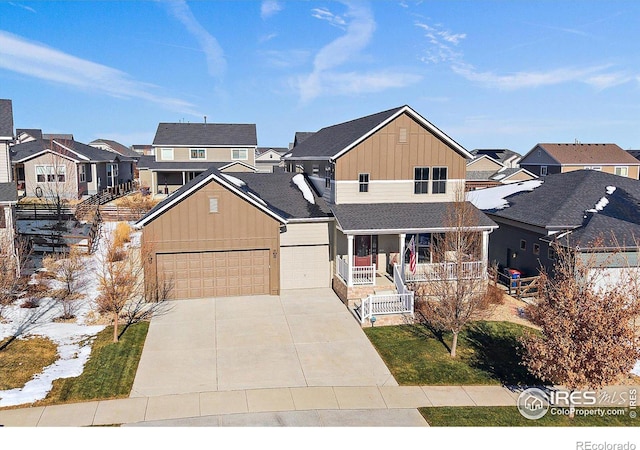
157,250,269,299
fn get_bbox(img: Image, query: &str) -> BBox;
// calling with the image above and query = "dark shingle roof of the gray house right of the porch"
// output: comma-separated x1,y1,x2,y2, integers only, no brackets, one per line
489,170,640,229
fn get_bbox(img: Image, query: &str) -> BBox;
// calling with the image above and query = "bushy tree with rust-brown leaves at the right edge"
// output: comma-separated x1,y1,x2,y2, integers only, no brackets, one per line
522,239,640,400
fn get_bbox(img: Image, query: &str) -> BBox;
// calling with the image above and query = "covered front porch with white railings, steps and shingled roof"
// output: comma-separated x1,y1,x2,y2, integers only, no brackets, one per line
332,200,496,324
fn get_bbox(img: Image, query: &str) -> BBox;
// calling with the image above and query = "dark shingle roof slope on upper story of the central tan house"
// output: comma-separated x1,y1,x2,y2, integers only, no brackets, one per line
284,107,403,159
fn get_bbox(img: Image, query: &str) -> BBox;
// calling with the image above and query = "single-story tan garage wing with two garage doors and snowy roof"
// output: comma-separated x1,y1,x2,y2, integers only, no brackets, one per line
136,167,333,299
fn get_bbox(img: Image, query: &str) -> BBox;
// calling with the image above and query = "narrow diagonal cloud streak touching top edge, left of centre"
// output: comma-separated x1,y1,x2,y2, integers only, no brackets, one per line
161,0,227,76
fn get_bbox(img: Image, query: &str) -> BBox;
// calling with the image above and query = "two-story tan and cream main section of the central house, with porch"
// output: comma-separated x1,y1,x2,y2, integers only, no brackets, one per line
285,106,496,310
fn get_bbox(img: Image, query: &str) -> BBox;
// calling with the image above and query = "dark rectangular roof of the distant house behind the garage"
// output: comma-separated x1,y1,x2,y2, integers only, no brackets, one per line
153,123,258,147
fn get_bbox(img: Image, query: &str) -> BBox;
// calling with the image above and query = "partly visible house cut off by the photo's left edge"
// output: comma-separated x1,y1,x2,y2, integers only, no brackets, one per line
0,99,18,255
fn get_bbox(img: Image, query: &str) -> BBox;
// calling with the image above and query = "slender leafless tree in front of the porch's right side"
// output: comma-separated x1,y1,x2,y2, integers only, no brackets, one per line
411,193,496,358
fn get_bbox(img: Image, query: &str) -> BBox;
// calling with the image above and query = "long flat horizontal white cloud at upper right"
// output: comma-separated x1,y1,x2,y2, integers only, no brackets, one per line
452,63,633,90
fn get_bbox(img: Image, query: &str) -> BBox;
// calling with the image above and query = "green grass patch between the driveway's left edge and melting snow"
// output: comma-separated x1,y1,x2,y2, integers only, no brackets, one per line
36,322,149,406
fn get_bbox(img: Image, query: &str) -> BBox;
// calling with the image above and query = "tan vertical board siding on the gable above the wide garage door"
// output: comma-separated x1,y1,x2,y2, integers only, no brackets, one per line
143,181,280,295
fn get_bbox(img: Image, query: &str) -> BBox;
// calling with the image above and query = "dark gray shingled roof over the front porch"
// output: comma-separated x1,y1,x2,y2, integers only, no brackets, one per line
331,202,498,234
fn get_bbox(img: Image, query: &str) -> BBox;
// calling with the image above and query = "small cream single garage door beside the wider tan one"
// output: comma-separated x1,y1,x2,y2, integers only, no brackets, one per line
280,245,331,289
